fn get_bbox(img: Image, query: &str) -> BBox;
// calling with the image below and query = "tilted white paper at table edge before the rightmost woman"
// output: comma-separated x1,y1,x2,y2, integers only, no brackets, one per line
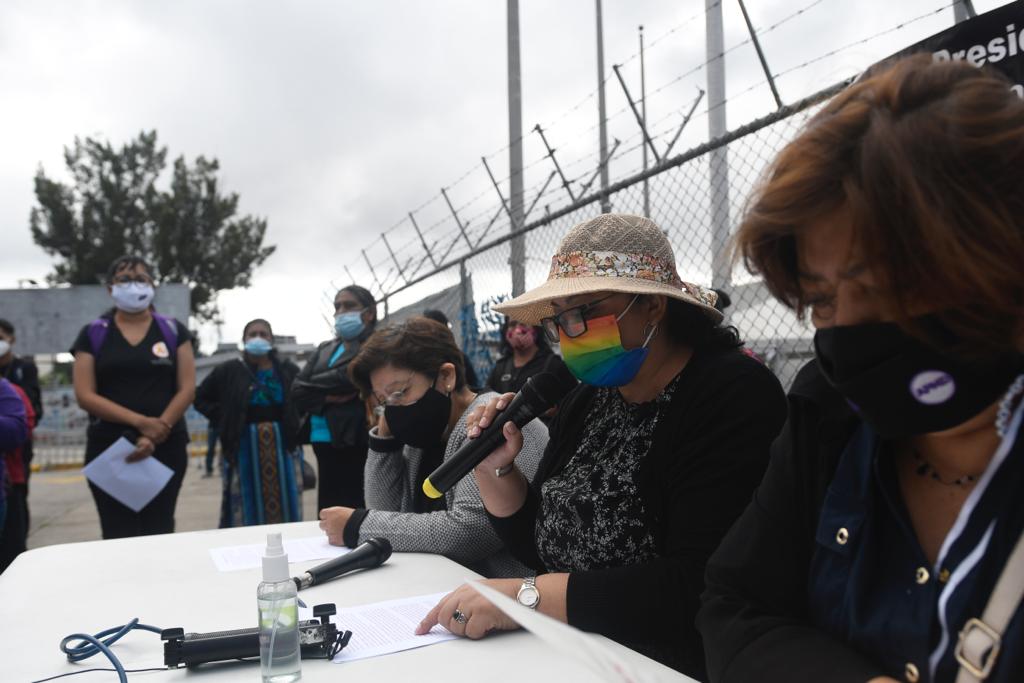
466,581,679,683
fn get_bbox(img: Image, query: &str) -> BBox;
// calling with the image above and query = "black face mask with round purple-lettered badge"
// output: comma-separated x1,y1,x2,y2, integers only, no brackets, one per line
814,318,1024,438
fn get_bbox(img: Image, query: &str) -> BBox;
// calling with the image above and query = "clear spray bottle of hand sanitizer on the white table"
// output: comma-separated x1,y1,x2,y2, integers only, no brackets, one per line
256,533,302,683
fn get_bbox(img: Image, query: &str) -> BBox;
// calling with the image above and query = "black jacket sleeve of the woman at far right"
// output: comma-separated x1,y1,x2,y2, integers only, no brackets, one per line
697,360,883,683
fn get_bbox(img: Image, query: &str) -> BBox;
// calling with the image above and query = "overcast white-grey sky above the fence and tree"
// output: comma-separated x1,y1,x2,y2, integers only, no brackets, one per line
0,0,1005,348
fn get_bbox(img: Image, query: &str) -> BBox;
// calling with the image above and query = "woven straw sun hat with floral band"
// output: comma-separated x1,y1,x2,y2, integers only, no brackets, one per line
495,213,722,325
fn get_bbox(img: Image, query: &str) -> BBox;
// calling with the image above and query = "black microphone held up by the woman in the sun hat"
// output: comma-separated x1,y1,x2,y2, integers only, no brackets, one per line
423,370,577,498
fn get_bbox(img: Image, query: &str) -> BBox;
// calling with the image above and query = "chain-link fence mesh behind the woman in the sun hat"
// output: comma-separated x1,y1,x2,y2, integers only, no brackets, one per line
367,82,847,387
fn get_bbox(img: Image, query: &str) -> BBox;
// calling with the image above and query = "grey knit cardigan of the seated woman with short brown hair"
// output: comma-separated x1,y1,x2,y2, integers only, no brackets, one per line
359,393,548,564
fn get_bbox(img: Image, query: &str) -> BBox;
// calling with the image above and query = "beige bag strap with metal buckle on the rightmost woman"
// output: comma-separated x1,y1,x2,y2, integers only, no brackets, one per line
955,533,1024,683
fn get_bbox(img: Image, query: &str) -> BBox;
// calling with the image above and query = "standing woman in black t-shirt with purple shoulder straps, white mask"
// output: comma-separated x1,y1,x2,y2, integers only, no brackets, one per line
72,256,196,539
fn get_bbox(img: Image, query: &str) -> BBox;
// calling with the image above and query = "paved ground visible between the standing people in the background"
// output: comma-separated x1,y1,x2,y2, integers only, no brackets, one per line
29,452,316,548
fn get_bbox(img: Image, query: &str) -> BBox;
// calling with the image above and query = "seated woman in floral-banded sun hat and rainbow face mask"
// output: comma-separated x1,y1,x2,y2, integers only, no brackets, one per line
420,214,785,678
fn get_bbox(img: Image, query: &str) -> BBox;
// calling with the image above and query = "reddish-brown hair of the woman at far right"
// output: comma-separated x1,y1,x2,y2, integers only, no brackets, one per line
736,55,1024,354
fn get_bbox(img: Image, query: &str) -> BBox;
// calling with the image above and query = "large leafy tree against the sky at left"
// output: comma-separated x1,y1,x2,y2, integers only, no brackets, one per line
30,131,274,321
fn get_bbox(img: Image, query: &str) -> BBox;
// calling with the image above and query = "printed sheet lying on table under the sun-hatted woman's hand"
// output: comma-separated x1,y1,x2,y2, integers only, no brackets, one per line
299,591,459,664
